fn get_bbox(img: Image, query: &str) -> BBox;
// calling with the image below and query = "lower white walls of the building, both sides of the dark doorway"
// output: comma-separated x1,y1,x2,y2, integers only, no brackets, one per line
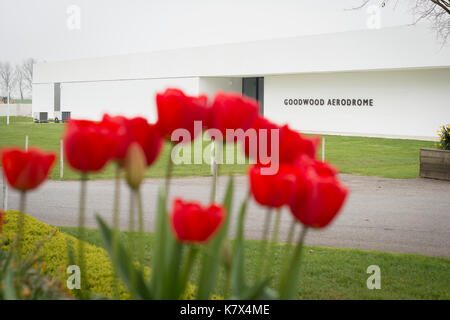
33,68,450,139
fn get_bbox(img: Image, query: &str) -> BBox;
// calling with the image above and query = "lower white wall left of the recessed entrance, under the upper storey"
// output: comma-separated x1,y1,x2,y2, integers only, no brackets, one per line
33,78,198,122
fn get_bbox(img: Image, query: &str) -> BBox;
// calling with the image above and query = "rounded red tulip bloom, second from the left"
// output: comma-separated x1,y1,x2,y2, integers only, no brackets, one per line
64,119,118,173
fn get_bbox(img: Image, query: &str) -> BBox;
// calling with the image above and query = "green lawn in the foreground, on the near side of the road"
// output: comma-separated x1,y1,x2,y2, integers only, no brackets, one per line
60,227,450,299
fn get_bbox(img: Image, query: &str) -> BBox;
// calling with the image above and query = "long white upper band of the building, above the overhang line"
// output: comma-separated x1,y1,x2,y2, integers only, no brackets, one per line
33,26,450,83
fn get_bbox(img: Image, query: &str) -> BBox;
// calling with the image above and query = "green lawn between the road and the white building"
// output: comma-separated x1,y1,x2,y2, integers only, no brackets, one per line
0,117,434,180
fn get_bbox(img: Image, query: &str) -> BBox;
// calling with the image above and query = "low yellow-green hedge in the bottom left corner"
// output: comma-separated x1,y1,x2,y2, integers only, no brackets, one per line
1,210,195,299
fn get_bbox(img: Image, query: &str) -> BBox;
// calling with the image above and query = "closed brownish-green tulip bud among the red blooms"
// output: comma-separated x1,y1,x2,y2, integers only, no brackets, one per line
125,142,146,190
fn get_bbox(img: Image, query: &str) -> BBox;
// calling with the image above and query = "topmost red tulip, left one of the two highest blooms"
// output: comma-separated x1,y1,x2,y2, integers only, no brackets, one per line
156,89,207,142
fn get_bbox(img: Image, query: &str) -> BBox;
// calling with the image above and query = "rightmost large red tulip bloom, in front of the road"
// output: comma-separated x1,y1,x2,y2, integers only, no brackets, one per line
289,156,348,228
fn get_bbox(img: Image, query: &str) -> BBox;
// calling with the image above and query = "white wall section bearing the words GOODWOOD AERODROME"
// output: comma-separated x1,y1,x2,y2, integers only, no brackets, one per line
264,68,450,138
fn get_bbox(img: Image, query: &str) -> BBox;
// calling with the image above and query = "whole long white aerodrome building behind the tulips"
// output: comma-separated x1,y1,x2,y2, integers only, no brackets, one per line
33,26,450,139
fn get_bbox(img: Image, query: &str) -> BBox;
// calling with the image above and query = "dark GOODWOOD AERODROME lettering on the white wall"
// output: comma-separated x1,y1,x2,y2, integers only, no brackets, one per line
283,98,374,107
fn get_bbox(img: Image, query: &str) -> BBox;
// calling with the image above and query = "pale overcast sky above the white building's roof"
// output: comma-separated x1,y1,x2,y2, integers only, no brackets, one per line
0,0,422,63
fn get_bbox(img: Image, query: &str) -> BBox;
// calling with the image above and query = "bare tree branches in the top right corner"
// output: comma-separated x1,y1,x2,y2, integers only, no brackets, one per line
353,0,450,45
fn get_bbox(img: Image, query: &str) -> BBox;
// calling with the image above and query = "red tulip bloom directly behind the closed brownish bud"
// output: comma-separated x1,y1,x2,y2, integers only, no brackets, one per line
102,114,162,166
